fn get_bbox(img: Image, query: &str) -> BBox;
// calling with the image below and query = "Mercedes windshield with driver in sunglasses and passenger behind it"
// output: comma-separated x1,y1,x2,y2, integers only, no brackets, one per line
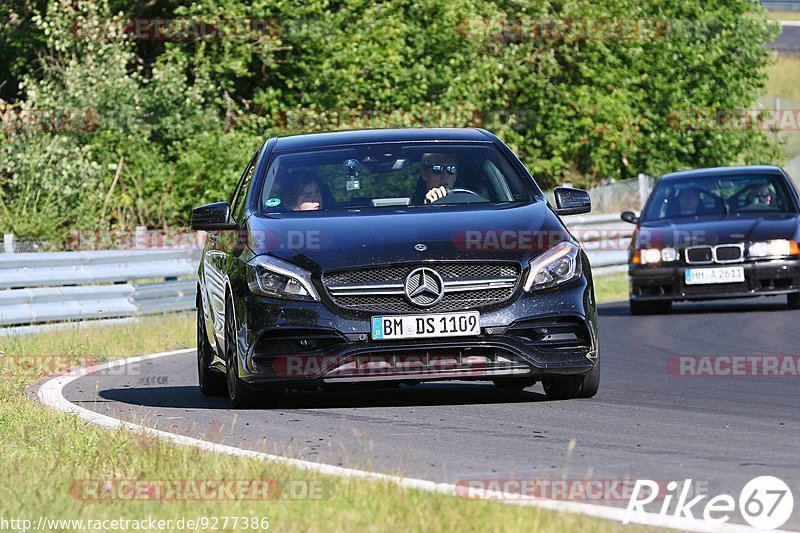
260,143,531,213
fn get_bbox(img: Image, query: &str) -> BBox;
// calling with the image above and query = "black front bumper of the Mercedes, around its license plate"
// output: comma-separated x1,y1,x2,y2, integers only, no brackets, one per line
237,277,598,388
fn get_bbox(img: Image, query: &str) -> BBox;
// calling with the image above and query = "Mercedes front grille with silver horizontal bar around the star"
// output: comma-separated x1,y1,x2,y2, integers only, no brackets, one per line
322,263,520,313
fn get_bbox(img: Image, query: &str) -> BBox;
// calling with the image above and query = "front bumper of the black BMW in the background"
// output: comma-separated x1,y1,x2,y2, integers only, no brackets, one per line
628,259,800,301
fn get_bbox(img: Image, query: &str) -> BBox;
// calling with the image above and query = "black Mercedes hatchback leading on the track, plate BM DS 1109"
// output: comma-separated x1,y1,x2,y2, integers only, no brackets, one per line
192,129,600,407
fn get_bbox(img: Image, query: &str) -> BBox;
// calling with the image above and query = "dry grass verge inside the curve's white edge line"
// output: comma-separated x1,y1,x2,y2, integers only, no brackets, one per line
0,315,636,531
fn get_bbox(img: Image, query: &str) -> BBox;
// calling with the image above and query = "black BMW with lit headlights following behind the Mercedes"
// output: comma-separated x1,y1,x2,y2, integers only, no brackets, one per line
622,166,800,315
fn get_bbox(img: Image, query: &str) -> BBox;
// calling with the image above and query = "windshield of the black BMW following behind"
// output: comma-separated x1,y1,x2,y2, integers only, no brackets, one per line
642,174,796,221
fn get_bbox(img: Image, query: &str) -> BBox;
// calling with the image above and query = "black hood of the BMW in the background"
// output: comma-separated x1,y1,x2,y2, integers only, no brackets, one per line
635,213,800,247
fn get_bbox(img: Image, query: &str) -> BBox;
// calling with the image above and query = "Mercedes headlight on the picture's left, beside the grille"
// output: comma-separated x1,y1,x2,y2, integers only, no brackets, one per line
247,255,319,301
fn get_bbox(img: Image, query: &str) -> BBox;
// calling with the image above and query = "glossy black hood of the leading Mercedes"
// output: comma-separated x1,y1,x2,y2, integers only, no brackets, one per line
248,202,569,271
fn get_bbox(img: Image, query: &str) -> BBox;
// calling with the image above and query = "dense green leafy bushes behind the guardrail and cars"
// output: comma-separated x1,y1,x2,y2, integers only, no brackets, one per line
0,0,777,242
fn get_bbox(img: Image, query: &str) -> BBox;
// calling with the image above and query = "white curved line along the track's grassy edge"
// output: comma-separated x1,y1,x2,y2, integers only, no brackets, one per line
37,349,768,533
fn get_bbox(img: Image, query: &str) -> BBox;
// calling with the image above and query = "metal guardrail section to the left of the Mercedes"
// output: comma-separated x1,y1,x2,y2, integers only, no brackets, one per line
0,249,200,326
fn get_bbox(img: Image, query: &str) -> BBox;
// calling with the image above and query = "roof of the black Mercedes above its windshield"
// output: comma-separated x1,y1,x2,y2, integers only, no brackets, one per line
274,128,492,151
